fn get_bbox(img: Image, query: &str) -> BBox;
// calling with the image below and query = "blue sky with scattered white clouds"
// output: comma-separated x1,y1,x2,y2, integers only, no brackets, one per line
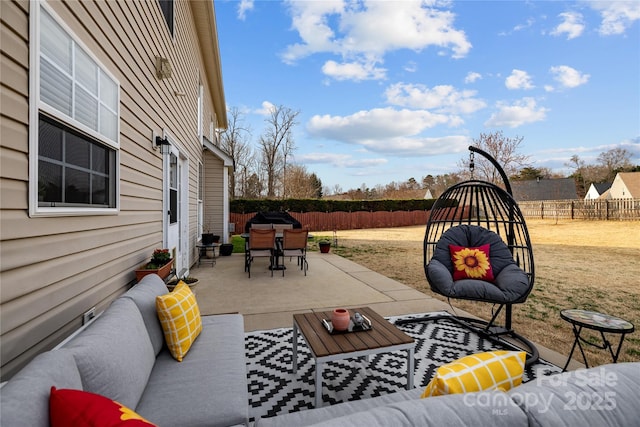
215,0,640,191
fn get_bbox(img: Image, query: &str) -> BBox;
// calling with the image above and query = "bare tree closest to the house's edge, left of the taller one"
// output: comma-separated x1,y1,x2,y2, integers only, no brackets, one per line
220,107,252,197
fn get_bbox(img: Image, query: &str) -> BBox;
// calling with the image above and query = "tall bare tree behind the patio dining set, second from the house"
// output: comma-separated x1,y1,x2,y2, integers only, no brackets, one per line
259,105,300,197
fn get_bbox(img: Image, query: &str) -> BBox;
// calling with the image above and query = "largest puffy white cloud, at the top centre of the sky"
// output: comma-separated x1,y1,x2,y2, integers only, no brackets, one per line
282,0,471,79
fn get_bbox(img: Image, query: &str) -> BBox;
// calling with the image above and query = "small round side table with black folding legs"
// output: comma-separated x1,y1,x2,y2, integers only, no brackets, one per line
560,309,635,372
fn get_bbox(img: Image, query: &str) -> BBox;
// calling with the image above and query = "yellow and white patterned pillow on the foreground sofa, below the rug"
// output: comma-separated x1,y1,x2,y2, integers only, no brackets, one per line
420,351,527,397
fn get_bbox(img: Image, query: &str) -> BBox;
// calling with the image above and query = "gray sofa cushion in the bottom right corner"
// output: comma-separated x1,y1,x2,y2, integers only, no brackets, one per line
508,362,640,427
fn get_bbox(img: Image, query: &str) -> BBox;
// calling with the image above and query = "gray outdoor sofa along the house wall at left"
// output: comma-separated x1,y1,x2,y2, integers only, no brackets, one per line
0,275,249,427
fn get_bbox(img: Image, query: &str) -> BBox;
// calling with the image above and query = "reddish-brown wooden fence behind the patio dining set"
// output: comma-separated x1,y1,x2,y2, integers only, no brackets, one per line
229,211,429,234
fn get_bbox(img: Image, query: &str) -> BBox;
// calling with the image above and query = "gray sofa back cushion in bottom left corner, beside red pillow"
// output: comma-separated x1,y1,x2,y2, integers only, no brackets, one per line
0,349,82,427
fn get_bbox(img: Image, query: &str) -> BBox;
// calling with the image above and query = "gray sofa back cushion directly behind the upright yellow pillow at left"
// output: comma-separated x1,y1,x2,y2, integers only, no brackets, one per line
122,274,169,355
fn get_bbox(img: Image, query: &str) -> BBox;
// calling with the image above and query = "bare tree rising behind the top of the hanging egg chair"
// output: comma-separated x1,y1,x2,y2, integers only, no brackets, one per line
461,131,529,184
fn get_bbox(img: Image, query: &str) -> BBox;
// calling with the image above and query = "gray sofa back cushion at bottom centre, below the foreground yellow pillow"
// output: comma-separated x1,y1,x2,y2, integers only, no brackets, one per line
313,391,528,427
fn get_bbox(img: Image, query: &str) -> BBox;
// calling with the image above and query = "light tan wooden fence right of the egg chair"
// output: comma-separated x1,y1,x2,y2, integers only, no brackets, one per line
518,199,640,221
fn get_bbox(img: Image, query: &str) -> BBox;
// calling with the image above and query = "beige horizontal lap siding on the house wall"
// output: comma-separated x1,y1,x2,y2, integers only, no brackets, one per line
0,1,226,380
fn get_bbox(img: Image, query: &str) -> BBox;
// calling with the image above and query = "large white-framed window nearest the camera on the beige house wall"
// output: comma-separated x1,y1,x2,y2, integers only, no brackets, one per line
29,2,120,216
